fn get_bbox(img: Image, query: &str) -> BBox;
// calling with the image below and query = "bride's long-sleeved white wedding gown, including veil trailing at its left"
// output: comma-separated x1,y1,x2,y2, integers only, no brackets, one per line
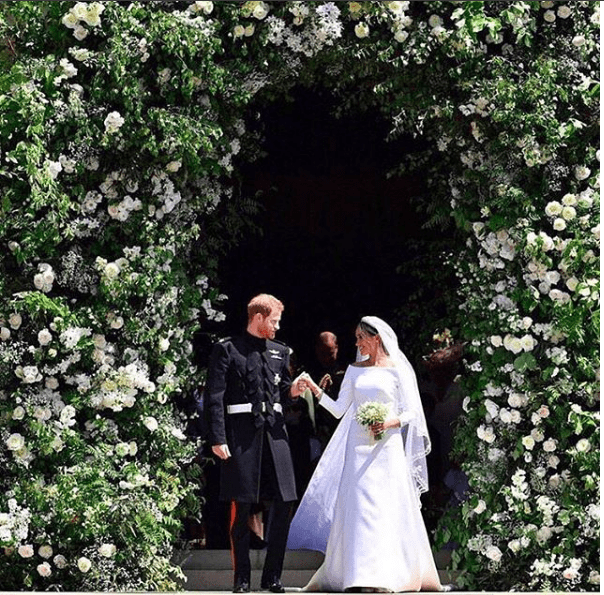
288,366,443,592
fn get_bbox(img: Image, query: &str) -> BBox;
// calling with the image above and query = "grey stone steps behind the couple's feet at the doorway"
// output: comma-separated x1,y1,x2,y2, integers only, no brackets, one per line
174,550,451,591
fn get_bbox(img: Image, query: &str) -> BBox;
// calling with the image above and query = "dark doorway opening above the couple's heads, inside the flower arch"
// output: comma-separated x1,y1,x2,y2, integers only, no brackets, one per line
220,89,437,364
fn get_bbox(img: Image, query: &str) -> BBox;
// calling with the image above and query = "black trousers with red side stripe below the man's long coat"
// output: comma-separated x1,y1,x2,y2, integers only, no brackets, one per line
230,435,293,583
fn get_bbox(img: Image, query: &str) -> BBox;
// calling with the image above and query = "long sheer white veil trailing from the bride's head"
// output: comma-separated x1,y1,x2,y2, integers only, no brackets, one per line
287,316,430,552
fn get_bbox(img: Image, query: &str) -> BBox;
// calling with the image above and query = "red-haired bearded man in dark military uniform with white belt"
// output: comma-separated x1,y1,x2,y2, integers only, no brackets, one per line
206,294,303,593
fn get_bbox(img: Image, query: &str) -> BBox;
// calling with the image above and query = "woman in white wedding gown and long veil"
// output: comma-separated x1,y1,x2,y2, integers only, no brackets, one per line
288,316,450,592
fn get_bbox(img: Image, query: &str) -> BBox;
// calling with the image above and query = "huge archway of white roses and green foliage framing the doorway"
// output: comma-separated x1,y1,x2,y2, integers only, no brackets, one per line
0,1,600,590
